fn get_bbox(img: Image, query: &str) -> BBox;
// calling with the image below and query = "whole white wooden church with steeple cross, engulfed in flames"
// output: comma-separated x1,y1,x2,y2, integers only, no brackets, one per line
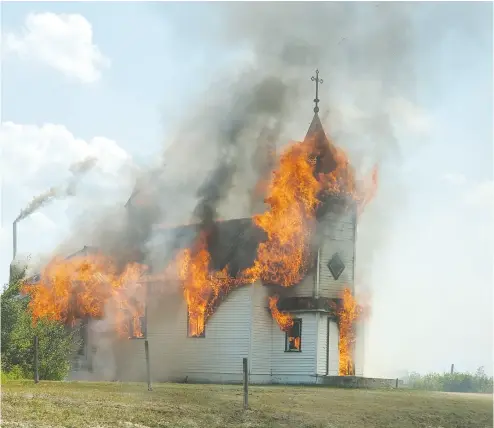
21,72,376,384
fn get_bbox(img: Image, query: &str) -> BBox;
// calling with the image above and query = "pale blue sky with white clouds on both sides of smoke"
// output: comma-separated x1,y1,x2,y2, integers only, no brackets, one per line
0,2,494,374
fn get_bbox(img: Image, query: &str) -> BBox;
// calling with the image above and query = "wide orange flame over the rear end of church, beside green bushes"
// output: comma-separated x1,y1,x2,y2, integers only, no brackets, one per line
22,254,146,337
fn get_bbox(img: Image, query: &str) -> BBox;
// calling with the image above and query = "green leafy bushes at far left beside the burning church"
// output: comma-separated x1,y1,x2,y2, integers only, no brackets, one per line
1,272,78,380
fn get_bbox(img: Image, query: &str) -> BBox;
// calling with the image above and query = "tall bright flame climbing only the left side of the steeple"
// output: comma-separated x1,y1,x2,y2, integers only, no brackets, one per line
244,143,321,287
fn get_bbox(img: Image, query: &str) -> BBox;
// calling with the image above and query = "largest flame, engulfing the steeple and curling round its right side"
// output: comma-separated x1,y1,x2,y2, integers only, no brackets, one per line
244,134,360,287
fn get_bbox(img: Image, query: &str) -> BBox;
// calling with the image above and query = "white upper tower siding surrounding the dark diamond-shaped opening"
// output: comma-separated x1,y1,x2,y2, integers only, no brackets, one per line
319,208,355,298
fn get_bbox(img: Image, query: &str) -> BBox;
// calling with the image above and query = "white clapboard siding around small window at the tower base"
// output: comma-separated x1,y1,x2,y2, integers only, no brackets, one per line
271,313,317,381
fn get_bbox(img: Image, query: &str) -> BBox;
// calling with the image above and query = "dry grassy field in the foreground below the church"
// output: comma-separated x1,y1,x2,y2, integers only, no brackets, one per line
1,381,493,428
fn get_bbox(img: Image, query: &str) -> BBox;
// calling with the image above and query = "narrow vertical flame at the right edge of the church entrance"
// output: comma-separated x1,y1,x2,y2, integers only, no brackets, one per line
338,288,362,376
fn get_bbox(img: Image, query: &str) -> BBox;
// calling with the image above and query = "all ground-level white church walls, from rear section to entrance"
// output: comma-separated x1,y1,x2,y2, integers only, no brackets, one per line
78,283,348,383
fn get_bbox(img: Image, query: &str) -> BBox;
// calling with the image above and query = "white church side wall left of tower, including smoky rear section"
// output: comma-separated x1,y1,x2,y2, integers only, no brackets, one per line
85,287,252,383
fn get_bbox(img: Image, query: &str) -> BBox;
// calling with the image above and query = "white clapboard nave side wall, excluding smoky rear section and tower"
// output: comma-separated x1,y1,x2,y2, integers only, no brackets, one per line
144,287,251,381
